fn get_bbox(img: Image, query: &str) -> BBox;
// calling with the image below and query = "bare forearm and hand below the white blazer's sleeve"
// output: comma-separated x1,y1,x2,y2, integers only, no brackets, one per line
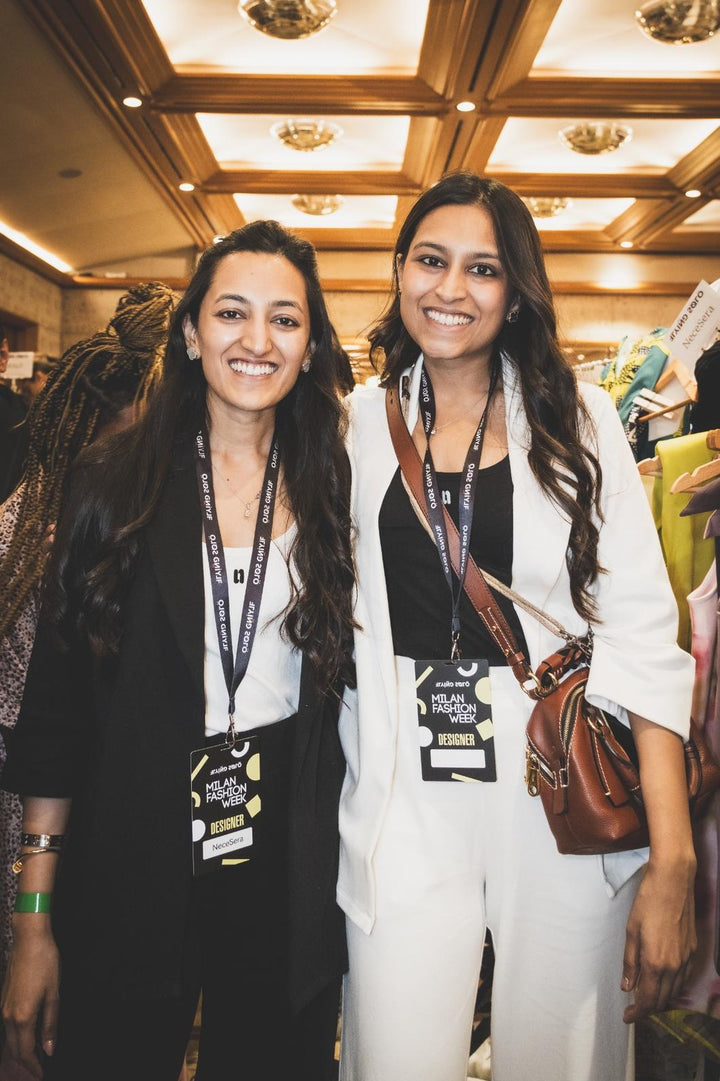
621,713,696,1023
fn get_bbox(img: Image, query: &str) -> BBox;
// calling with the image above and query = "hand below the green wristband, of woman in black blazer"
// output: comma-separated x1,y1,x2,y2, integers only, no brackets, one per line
2,912,59,1079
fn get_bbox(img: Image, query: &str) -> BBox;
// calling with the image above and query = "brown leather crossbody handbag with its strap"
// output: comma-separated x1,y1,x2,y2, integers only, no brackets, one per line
386,388,720,855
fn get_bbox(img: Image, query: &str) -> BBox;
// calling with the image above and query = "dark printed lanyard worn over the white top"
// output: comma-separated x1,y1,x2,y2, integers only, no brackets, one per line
196,430,280,746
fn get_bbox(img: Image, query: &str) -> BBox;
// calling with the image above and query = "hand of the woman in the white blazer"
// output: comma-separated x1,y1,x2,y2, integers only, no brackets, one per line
621,857,697,1024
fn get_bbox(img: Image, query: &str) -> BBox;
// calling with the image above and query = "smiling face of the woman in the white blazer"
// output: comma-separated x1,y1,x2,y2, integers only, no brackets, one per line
398,205,515,376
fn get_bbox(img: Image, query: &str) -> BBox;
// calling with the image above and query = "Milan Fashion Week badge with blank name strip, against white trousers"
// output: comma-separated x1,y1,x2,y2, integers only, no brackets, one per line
415,659,496,780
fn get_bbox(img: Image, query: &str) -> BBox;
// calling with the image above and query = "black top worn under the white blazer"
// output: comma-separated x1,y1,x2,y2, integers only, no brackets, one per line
379,455,526,665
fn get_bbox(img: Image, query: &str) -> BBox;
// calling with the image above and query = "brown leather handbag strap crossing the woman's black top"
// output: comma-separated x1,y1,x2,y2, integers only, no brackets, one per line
385,387,591,698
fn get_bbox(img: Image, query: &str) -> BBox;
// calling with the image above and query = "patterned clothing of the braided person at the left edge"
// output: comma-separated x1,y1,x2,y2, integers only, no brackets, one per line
0,489,38,984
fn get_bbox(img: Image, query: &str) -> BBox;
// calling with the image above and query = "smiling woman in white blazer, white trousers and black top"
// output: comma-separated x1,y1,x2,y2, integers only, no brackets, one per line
338,173,695,1081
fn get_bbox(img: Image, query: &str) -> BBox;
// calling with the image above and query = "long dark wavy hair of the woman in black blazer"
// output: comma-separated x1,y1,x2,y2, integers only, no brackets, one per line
51,221,355,691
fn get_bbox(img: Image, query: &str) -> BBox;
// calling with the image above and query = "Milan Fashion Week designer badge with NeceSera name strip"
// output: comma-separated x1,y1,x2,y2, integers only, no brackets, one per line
190,735,261,877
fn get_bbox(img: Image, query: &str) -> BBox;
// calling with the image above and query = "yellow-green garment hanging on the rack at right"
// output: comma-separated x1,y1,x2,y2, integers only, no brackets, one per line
653,431,715,652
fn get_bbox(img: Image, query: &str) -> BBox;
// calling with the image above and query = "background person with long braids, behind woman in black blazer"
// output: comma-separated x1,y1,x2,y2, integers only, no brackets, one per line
0,282,175,1073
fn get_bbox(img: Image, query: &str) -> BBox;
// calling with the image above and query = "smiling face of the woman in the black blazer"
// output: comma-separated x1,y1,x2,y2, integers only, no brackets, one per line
184,252,310,416
